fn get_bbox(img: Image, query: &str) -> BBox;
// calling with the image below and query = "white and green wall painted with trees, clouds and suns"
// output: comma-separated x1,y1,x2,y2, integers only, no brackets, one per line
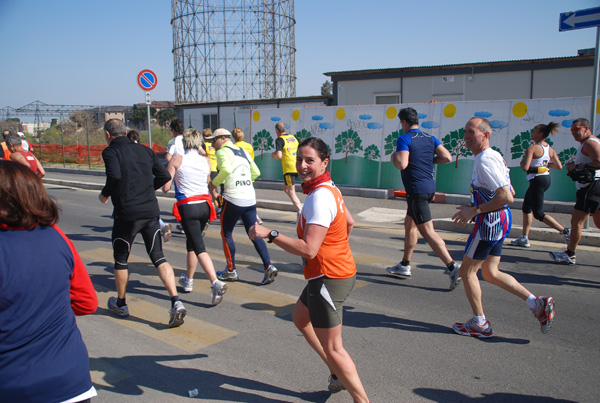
250,97,600,201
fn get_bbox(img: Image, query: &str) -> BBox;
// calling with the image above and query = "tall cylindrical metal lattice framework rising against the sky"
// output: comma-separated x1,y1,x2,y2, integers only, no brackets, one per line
171,0,296,103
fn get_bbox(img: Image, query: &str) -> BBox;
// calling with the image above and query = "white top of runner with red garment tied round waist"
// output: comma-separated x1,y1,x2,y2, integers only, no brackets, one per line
174,149,210,200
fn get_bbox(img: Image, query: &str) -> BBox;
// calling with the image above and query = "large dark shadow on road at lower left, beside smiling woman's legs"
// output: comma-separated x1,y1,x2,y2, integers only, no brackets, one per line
90,354,330,403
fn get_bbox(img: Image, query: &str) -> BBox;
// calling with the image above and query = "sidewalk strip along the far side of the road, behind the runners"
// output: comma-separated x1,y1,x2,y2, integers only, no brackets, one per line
42,167,600,246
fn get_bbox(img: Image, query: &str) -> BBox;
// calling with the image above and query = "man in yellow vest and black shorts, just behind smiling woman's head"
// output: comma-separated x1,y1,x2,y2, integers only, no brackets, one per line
271,122,302,213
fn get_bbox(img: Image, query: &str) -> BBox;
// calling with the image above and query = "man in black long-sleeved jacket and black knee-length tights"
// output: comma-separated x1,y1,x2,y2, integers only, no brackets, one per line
98,119,186,327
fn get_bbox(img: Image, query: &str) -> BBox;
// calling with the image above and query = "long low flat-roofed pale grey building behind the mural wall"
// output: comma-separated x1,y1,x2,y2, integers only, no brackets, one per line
325,49,594,105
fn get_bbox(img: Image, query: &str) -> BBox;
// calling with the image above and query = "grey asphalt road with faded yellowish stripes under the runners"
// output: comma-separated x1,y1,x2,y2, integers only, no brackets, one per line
49,184,600,403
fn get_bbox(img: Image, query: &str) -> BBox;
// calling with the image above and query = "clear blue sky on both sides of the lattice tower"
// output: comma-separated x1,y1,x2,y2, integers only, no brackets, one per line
0,0,600,108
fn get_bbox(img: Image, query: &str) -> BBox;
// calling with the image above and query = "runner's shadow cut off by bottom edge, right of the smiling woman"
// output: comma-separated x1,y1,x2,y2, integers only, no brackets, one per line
413,388,575,403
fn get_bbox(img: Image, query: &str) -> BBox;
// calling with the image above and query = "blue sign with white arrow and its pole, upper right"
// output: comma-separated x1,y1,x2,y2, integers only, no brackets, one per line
558,7,600,135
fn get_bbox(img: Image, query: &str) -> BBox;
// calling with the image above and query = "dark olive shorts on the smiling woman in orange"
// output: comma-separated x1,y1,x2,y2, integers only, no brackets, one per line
300,275,356,329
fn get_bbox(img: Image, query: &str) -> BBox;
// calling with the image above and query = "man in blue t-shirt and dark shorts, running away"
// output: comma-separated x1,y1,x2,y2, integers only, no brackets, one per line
386,108,460,291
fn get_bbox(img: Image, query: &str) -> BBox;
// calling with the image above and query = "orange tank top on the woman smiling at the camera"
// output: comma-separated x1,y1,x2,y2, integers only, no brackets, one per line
296,184,356,280
